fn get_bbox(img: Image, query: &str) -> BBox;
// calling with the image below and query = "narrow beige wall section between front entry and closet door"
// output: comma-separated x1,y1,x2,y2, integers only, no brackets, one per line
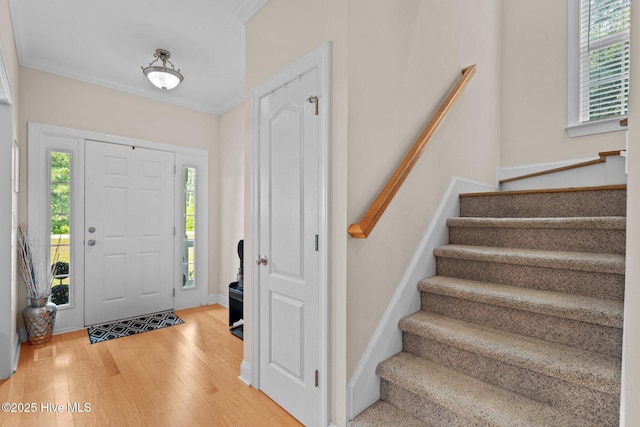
216,104,242,295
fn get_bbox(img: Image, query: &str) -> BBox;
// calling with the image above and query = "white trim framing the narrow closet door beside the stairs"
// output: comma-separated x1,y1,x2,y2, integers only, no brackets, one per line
249,43,331,426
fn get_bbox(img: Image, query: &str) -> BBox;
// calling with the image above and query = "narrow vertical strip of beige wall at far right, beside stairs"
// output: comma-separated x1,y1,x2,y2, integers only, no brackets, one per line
620,0,640,427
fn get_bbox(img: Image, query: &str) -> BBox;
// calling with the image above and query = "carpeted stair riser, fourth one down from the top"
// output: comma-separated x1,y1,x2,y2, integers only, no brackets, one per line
421,292,622,356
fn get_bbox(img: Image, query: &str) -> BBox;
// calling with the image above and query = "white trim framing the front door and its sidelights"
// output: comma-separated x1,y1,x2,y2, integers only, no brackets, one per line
28,122,209,333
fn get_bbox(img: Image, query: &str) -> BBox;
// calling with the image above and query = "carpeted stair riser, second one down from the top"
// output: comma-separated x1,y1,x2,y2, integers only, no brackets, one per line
449,227,626,254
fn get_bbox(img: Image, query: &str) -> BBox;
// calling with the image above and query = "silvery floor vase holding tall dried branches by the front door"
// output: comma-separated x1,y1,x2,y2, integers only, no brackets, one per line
18,225,58,345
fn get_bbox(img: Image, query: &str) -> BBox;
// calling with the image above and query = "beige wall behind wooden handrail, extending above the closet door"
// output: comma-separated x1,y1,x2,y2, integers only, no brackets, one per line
245,0,500,425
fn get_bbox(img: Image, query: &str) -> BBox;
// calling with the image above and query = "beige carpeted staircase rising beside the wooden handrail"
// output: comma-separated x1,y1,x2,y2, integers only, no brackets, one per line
351,186,626,427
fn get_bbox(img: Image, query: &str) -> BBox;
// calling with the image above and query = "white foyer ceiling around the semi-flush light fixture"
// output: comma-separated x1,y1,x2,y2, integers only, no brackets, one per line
10,0,268,114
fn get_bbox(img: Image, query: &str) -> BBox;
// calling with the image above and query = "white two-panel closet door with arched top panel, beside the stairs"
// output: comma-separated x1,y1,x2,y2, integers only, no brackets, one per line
256,68,320,426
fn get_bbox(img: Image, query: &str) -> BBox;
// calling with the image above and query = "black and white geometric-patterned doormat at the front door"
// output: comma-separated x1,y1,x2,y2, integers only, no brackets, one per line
87,311,184,344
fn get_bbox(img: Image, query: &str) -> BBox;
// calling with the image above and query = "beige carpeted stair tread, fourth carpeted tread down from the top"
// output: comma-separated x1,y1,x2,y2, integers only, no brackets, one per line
399,311,621,393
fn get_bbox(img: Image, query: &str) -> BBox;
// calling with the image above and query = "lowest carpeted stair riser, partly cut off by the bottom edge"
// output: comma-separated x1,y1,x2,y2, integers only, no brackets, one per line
380,379,487,427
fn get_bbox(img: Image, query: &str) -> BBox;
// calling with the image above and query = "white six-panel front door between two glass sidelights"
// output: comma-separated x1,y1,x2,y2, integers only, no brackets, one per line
84,141,175,325
